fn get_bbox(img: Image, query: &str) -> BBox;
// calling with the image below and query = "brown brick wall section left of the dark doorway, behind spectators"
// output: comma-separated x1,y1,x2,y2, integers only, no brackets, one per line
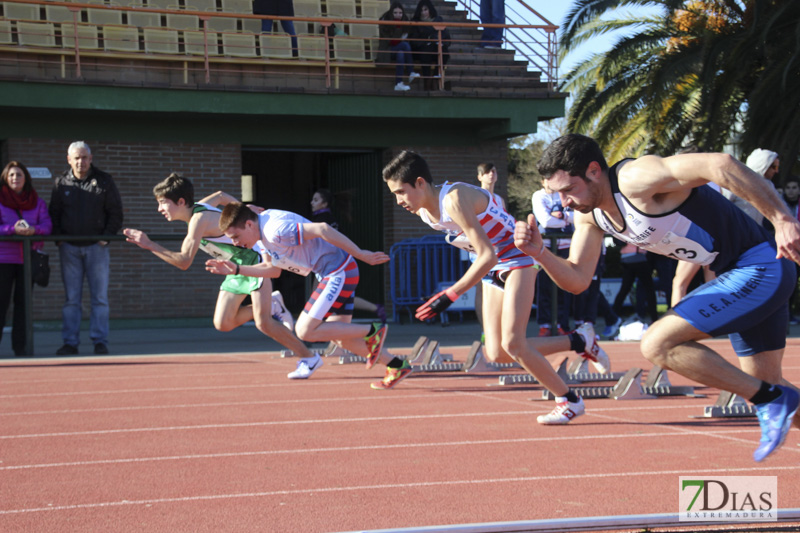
3,138,241,324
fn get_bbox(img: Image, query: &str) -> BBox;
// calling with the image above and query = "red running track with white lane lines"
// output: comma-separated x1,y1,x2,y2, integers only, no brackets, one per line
0,339,800,533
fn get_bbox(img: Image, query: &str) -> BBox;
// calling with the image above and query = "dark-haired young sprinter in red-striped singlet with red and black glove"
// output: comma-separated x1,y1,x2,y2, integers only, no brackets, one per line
383,151,608,424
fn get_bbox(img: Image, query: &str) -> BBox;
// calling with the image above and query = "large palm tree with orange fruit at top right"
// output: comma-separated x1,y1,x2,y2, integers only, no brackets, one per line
561,0,800,167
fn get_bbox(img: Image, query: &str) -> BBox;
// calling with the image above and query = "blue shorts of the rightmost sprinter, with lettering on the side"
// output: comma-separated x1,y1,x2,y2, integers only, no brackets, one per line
674,242,797,357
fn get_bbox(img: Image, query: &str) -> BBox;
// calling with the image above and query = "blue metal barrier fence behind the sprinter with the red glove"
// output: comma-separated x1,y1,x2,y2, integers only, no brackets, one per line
389,235,470,322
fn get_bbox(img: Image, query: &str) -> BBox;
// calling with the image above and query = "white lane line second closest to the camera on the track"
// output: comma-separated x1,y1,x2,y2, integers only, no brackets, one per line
0,428,752,471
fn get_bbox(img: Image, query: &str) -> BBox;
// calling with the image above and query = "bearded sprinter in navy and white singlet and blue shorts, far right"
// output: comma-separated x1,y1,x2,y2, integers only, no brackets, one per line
514,134,800,461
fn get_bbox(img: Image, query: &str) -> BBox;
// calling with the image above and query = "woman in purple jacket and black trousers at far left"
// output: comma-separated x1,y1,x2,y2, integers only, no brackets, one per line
0,161,53,356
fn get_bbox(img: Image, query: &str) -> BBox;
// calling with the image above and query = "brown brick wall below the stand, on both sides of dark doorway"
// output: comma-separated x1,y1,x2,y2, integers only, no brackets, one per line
2,139,507,325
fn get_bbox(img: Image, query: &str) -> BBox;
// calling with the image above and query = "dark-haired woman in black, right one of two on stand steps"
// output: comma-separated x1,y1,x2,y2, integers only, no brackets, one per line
409,0,451,91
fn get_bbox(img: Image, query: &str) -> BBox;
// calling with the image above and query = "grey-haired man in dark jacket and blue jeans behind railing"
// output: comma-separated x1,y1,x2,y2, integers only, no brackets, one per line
50,141,122,355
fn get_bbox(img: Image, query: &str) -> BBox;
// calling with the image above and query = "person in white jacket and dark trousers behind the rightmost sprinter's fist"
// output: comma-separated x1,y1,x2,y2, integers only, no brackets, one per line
531,181,574,337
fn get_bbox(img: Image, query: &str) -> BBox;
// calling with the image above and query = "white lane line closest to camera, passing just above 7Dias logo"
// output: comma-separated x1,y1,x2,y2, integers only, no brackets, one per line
0,465,800,515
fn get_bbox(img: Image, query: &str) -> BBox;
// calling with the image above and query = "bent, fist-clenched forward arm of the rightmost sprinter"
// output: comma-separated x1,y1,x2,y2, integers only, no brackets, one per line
514,213,604,294
